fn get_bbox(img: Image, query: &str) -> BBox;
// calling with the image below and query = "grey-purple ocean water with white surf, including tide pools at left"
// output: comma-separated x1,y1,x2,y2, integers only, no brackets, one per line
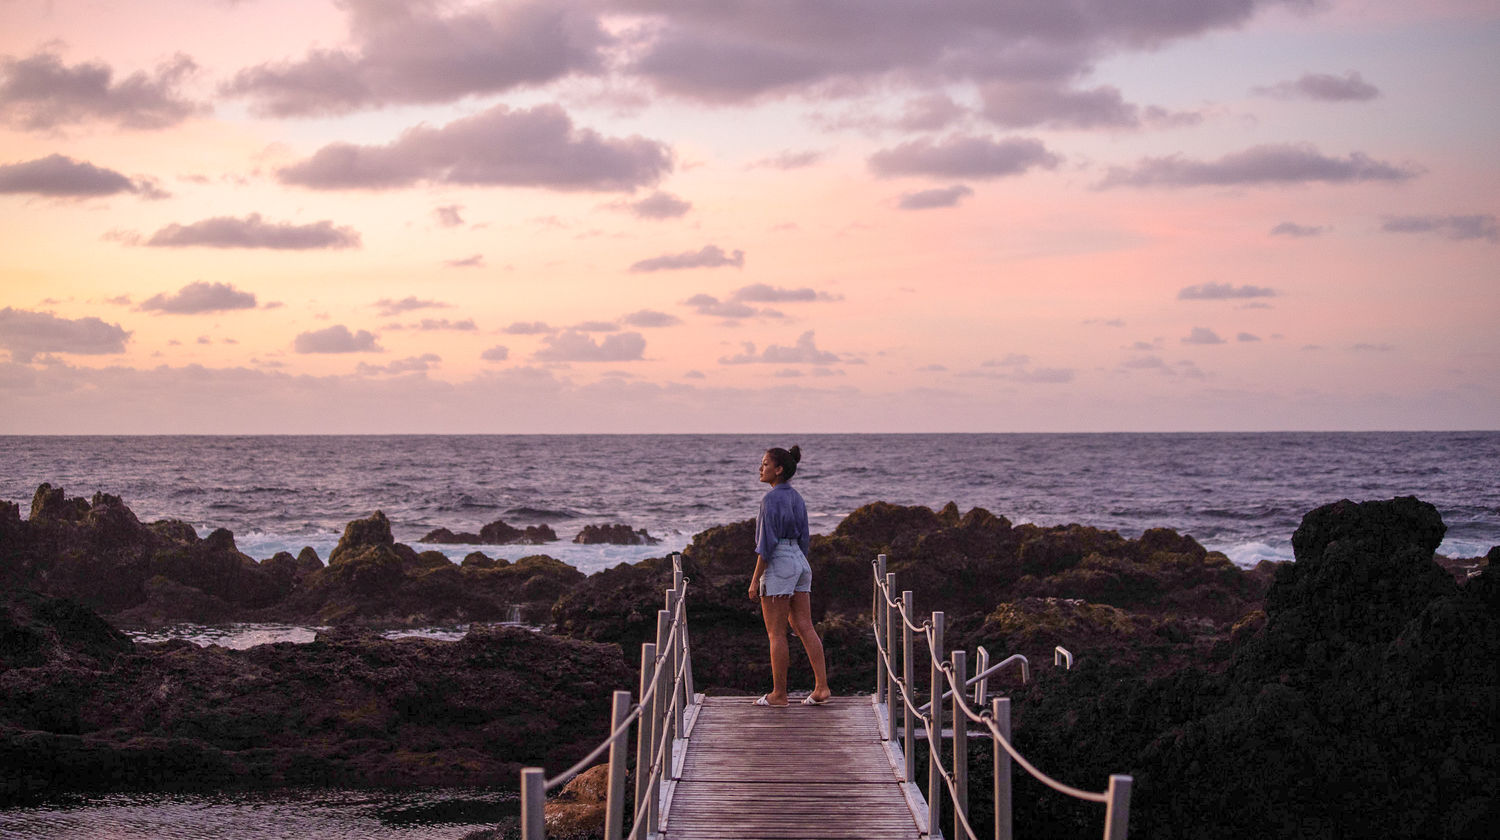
0,432,1500,840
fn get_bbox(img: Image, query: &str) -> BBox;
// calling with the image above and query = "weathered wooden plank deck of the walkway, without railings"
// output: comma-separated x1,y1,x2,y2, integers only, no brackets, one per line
660,698,927,840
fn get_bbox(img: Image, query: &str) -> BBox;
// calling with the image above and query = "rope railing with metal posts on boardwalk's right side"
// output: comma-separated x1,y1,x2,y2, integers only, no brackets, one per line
870,554,1133,840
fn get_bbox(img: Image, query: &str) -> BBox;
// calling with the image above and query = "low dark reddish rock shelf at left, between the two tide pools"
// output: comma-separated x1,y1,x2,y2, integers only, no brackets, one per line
0,593,632,803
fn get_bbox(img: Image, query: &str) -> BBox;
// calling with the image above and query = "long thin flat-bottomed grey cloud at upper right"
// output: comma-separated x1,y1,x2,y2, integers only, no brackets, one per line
1098,144,1421,189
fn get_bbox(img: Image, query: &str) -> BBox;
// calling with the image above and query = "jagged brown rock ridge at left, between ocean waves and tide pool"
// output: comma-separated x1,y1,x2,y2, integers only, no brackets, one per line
0,485,584,627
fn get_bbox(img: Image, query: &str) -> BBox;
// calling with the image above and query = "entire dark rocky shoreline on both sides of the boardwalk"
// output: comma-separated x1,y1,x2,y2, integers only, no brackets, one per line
0,485,1500,837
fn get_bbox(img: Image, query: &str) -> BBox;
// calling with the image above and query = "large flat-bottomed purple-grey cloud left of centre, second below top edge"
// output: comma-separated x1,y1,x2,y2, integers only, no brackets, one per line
278,105,672,192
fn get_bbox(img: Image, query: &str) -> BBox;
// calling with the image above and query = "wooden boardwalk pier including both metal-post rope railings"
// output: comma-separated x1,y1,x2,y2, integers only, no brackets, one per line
521,555,1131,840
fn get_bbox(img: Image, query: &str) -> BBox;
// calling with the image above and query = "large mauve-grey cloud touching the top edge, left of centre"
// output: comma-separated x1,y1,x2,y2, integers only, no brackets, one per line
224,0,609,117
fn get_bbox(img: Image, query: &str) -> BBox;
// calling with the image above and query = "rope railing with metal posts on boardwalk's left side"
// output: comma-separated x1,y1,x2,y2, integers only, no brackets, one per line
521,554,695,840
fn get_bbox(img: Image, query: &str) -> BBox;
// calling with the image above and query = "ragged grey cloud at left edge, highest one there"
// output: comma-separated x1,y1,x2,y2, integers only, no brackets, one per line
0,53,206,131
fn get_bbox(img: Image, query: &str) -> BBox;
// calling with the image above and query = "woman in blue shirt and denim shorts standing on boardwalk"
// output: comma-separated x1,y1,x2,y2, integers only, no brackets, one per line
750,446,833,707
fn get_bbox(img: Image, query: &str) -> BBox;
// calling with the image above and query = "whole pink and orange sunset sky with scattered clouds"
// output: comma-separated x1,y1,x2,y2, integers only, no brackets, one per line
0,0,1500,434
